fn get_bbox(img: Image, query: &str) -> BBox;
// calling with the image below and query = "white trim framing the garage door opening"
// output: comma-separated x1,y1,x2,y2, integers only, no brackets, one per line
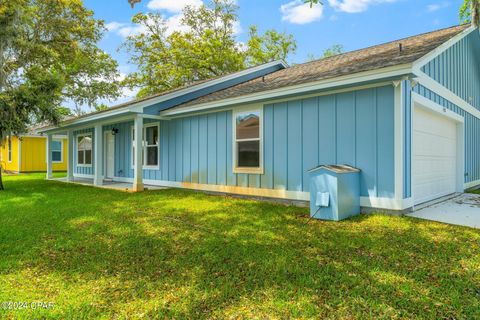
410,92,465,209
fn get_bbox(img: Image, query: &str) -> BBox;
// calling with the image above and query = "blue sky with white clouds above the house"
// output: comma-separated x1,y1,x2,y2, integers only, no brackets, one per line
80,0,463,111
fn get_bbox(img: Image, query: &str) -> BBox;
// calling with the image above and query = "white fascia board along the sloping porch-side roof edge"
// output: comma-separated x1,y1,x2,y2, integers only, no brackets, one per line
39,60,288,133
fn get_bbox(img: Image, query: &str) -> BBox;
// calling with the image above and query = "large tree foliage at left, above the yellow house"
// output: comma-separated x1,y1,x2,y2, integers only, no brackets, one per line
0,0,124,189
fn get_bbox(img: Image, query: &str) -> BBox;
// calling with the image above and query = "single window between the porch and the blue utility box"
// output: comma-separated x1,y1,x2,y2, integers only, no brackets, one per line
234,109,263,173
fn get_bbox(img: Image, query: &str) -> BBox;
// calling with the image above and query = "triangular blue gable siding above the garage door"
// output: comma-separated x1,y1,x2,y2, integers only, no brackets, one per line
422,30,480,110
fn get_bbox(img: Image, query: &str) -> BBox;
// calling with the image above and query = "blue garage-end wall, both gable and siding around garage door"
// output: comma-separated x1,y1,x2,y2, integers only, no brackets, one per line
403,30,480,198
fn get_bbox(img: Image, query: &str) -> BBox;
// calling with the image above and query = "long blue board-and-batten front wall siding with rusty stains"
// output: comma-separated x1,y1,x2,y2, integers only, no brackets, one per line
104,86,394,198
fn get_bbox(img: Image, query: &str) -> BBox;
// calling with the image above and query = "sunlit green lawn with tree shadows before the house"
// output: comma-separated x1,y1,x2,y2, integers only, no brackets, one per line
0,174,480,319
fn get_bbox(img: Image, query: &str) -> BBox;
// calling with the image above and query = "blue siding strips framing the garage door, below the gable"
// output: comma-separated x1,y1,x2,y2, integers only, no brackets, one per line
404,81,480,198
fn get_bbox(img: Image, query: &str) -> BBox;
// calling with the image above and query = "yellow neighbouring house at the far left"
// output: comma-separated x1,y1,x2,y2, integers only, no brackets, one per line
0,134,68,172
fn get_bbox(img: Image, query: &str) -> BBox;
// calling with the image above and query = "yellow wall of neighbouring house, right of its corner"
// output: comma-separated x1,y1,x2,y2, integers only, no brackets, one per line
21,137,68,172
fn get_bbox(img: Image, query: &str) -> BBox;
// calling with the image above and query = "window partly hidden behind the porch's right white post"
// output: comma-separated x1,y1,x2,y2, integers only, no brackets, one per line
132,124,159,169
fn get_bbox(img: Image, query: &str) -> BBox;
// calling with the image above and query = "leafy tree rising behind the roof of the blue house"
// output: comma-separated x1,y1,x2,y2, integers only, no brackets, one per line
123,0,296,97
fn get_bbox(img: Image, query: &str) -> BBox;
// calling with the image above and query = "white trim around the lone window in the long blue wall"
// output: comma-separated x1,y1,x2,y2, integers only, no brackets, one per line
232,104,264,174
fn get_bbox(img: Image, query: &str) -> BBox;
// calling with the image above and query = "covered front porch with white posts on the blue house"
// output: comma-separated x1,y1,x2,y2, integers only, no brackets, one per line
43,113,161,192
